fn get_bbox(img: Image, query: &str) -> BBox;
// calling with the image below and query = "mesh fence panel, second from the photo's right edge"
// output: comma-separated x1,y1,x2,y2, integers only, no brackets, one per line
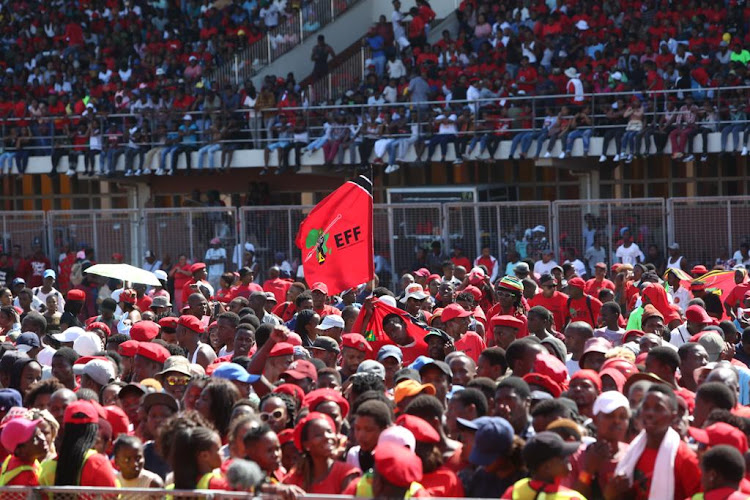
552,198,667,274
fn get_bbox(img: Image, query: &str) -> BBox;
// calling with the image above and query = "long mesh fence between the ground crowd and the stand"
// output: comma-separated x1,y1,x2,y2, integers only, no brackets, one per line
0,196,750,286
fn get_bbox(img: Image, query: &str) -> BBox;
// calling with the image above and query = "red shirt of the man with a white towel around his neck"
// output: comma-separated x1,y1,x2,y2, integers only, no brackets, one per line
632,441,701,500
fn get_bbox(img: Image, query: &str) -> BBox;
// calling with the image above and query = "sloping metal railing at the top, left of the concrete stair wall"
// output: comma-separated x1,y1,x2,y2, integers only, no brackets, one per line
209,0,366,85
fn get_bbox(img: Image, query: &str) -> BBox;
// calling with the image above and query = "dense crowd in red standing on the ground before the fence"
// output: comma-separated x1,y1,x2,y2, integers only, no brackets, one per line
0,231,750,500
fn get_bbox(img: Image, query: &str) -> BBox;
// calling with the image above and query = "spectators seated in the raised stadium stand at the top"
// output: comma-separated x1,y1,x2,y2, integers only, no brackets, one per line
0,0,750,176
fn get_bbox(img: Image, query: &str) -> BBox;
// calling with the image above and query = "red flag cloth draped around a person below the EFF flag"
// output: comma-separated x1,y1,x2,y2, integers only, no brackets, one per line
352,299,428,366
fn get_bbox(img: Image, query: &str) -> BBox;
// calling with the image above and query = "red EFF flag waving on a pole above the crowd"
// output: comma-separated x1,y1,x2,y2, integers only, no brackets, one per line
296,176,375,295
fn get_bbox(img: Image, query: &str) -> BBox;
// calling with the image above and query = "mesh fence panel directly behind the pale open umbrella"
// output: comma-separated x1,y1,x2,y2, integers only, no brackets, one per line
47,209,142,264
